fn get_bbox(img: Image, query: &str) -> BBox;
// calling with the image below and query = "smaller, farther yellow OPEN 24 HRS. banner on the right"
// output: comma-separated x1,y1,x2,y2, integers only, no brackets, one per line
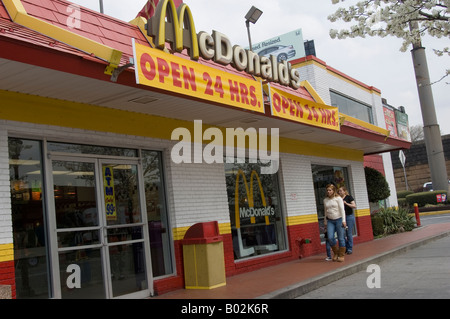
270,86,340,131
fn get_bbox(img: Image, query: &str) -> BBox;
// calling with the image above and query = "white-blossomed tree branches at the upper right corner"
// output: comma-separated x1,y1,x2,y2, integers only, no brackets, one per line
328,0,450,82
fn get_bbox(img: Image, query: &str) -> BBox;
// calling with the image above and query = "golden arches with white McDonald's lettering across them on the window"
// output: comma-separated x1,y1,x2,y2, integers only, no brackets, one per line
234,169,275,228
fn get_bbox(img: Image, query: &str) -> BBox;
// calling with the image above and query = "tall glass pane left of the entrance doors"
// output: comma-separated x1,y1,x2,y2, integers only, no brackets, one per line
8,138,50,299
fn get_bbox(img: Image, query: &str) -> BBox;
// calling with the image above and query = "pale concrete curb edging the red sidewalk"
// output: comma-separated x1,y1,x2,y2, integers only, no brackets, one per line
255,231,450,299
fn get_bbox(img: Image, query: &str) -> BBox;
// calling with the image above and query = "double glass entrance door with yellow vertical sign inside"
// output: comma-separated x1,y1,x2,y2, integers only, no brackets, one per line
50,157,151,298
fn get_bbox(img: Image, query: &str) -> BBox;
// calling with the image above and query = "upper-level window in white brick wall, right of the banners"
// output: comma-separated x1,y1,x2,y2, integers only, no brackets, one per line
330,91,373,124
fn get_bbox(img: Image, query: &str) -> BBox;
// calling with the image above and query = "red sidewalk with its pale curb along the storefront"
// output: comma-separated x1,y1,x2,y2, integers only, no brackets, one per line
155,223,450,299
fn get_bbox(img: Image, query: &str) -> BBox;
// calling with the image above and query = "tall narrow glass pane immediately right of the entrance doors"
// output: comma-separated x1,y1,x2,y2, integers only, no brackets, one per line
142,150,173,277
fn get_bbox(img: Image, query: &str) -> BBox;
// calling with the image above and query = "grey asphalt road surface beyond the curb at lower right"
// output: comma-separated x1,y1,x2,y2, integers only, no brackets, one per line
297,214,450,299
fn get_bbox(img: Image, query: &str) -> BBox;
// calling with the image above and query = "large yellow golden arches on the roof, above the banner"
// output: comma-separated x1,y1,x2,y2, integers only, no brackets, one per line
147,0,199,60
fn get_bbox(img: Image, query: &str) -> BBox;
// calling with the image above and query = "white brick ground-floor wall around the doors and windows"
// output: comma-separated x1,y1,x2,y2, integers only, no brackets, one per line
0,121,369,243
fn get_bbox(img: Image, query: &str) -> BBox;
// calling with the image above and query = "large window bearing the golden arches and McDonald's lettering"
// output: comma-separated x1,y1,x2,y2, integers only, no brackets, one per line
225,163,286,259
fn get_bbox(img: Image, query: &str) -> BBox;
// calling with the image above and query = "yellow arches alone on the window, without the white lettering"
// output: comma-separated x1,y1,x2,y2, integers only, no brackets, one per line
234,169,270,228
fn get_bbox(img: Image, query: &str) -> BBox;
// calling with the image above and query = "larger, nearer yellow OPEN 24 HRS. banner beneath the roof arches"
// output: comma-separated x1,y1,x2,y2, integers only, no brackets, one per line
134,43,264,113
